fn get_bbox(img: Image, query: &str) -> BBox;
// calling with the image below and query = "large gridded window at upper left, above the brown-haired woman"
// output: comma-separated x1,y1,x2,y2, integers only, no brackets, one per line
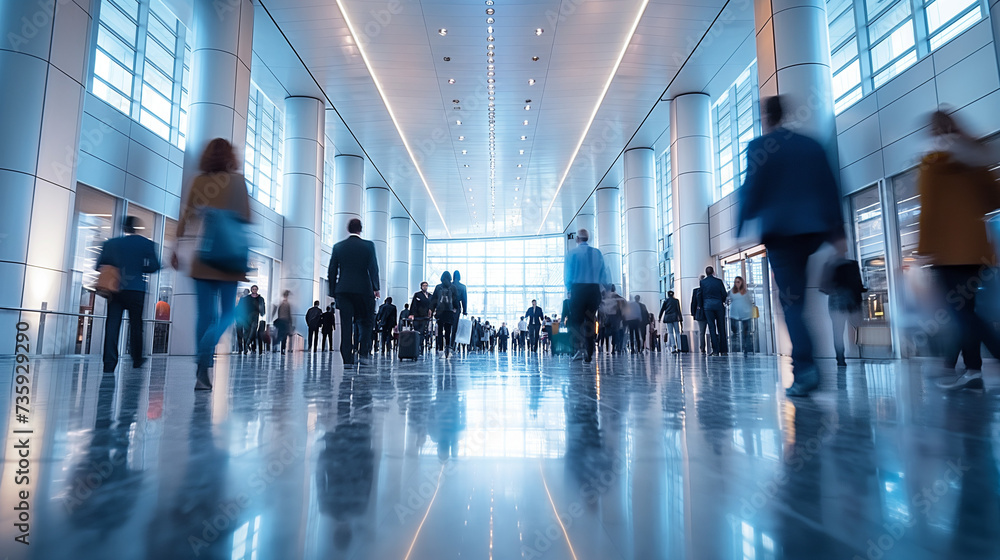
90,0,191,148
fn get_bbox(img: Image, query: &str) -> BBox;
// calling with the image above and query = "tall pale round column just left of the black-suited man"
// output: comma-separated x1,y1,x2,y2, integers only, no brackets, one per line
279,97,326,334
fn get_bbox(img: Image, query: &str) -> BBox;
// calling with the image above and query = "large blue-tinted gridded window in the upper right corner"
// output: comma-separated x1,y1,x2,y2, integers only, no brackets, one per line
826,0,986,113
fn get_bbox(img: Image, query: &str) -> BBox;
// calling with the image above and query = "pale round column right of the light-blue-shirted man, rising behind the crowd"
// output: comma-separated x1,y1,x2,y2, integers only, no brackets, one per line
623,148,660,313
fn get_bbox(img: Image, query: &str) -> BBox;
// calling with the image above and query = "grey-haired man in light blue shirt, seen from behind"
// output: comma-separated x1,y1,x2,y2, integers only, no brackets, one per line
564,229,611,363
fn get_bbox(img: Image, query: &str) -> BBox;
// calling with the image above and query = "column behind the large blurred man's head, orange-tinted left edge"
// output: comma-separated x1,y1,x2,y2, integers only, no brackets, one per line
754,0,838,162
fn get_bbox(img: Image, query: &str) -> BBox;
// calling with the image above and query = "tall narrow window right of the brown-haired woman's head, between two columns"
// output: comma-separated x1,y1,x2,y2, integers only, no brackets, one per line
244,82,285,213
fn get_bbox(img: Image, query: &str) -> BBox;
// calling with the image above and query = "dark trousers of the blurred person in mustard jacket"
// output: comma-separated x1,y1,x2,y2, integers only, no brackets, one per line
934,265,1000,370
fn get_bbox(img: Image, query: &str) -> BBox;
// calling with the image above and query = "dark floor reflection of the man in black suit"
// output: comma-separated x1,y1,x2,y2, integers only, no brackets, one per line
316,371,375,550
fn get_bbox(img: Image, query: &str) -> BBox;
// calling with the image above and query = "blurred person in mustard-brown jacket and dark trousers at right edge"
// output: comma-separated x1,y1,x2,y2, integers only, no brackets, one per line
917,111,1000,389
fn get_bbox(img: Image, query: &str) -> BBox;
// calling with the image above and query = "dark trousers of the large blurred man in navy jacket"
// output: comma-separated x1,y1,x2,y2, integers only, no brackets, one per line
764,234,824,373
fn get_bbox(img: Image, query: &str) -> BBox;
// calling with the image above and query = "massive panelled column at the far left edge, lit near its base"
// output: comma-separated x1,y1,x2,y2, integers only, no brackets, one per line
0,0,96,354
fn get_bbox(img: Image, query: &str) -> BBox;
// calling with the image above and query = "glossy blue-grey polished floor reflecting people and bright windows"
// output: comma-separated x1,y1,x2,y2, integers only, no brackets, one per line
0,353,1000,560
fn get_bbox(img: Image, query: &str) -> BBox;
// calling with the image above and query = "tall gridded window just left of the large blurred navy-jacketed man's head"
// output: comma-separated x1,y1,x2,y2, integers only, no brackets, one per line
713,62,760,200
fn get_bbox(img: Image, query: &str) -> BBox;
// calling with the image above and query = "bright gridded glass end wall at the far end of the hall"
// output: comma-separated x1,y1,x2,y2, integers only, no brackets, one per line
425,235,566,327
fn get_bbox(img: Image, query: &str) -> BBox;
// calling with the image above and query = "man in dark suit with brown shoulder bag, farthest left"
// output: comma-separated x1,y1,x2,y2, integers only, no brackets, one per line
95,216,160,373
